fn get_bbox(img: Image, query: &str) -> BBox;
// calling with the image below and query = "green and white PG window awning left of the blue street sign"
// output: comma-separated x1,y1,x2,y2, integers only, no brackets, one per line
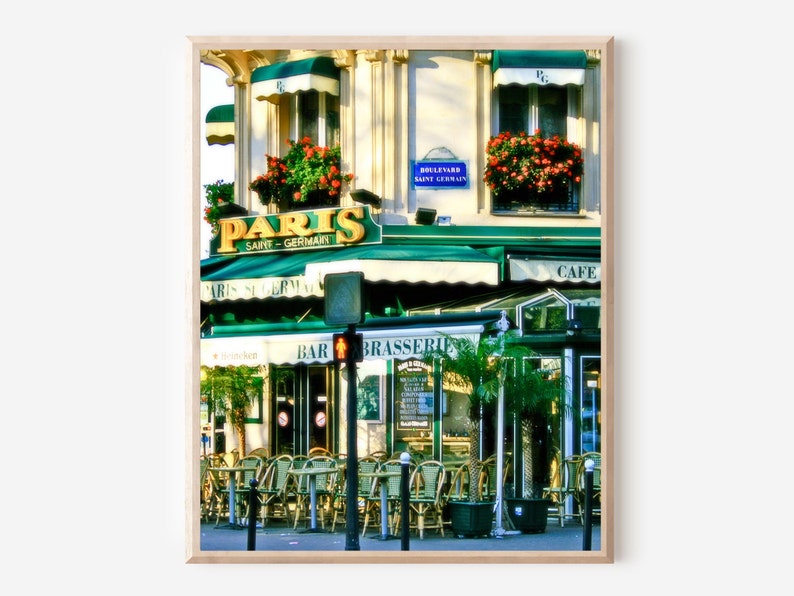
251,56,339,101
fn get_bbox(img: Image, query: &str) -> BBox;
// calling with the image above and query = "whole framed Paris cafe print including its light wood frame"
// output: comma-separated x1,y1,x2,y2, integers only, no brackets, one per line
186,36,615,563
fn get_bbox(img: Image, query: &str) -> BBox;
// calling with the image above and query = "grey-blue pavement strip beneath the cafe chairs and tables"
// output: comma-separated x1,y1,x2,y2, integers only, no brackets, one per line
201,518,601,552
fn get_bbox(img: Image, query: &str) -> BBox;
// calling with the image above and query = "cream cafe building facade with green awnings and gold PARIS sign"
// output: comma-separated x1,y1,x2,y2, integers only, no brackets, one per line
200,48,603,494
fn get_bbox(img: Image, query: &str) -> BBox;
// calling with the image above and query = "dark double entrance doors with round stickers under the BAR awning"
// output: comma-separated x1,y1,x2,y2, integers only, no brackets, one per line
271,364,336,455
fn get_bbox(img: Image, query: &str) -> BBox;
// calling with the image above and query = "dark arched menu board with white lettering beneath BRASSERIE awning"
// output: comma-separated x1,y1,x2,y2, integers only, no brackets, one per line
394,360,433,431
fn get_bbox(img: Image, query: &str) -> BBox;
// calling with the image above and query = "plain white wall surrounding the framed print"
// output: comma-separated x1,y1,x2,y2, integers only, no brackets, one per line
0,0,794,594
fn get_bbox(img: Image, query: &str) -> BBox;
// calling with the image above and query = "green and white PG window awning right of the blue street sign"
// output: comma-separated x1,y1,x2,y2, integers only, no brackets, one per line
491,50,587,87
